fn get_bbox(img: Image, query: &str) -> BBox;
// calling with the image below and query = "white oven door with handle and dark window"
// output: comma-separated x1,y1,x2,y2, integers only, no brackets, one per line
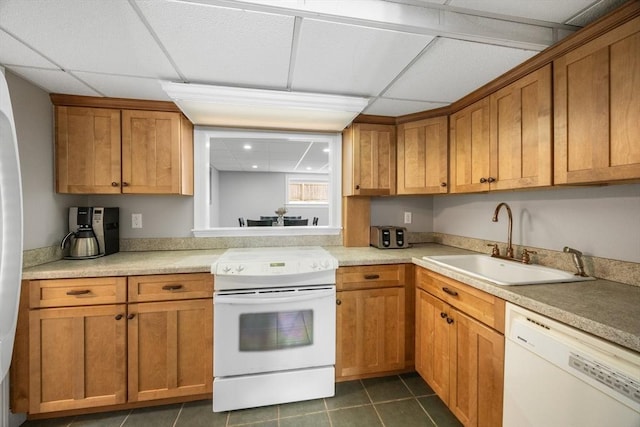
213,285,336,377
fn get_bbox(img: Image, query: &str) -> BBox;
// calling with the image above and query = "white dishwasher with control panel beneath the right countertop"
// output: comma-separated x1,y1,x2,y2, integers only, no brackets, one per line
503,303,640,427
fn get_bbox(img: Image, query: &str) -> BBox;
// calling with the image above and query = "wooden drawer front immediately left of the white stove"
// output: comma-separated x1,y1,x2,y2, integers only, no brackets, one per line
128,273,213,302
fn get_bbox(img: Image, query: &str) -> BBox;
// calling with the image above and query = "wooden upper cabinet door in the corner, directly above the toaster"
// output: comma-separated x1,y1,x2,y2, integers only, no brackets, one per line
397,116,449,194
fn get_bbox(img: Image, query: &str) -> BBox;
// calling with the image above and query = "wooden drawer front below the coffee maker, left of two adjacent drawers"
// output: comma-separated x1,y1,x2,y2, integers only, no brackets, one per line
29,277,127,308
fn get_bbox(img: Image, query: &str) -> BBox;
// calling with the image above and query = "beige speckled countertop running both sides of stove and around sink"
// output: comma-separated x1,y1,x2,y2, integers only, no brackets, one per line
23,243,640,352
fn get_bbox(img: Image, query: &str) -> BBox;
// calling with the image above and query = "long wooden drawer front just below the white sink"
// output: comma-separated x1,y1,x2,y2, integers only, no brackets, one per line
416,268,504,334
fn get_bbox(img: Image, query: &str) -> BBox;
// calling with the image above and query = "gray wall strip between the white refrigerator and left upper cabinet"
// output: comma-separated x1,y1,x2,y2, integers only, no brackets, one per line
6,70,86,250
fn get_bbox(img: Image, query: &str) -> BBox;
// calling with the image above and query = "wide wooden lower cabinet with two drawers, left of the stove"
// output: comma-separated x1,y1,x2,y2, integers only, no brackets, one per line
11,273,213,414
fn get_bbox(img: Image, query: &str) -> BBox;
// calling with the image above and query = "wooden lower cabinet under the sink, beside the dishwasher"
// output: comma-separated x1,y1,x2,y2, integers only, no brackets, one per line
415,267,504,427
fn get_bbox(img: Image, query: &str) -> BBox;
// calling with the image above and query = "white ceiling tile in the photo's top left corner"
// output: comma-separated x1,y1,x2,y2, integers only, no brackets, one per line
0,0,178,79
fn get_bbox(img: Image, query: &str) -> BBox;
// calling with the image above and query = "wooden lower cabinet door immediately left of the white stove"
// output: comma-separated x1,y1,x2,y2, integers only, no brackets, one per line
128,298,213,402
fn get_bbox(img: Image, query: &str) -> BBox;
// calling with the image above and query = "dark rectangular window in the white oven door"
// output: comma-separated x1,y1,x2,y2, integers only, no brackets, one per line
240,310,313,351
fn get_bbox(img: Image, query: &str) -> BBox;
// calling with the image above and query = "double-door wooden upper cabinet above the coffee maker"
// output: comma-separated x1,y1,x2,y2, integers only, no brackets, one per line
56,105,193,195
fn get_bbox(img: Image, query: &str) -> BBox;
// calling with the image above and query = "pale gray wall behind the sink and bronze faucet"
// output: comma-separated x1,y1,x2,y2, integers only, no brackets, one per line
433,184,640,262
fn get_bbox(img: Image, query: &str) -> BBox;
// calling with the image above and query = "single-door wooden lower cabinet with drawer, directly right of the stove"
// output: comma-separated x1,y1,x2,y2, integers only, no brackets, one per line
336,264,414,381
